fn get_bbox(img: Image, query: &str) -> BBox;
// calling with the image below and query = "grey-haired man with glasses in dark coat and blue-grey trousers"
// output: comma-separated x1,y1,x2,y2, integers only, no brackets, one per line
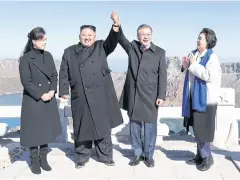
119,24,167,167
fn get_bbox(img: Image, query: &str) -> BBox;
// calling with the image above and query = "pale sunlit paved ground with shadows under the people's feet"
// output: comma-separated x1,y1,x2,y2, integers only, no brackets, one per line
0,136,240,180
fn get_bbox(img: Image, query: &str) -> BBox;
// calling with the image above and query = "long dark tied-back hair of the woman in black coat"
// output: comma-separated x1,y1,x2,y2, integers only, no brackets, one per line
19,27,46,60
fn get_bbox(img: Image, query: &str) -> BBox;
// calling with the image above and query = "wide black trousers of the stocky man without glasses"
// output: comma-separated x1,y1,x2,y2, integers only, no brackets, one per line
75,133,113,163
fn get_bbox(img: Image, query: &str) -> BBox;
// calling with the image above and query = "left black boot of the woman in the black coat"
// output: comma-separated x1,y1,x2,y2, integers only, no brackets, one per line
30,147,41,174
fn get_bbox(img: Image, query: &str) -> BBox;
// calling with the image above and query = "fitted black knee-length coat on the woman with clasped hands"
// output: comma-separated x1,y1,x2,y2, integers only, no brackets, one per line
19,50,62,147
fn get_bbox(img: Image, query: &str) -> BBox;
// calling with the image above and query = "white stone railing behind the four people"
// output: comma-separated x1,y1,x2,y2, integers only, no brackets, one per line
0,88,240,147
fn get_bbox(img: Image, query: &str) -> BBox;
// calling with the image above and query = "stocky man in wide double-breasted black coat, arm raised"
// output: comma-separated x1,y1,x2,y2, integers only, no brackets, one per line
59,12,123,168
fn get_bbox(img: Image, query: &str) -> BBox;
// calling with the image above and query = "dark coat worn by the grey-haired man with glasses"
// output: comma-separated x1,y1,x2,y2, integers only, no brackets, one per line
119,27,167,122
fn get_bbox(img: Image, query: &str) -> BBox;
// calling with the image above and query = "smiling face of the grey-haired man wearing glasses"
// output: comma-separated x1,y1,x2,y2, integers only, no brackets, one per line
138,27,152,46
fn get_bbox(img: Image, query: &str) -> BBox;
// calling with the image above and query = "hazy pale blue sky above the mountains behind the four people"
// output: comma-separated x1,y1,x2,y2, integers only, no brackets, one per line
0,1,240,71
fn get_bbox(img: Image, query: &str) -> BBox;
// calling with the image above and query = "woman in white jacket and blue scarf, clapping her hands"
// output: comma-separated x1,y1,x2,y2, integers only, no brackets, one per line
182,28,221,171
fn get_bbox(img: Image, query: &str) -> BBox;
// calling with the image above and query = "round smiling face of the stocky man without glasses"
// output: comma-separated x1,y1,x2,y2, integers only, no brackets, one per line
79,28,96,47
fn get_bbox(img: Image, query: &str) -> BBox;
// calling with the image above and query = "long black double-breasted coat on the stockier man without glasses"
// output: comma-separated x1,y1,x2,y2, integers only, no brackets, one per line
59,26,123,142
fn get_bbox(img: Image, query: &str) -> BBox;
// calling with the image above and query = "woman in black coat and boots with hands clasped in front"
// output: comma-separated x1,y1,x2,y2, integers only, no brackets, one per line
19,27,61,174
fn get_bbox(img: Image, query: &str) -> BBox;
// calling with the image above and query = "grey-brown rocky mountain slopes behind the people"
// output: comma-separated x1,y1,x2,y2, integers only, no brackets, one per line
0,57,240,107
